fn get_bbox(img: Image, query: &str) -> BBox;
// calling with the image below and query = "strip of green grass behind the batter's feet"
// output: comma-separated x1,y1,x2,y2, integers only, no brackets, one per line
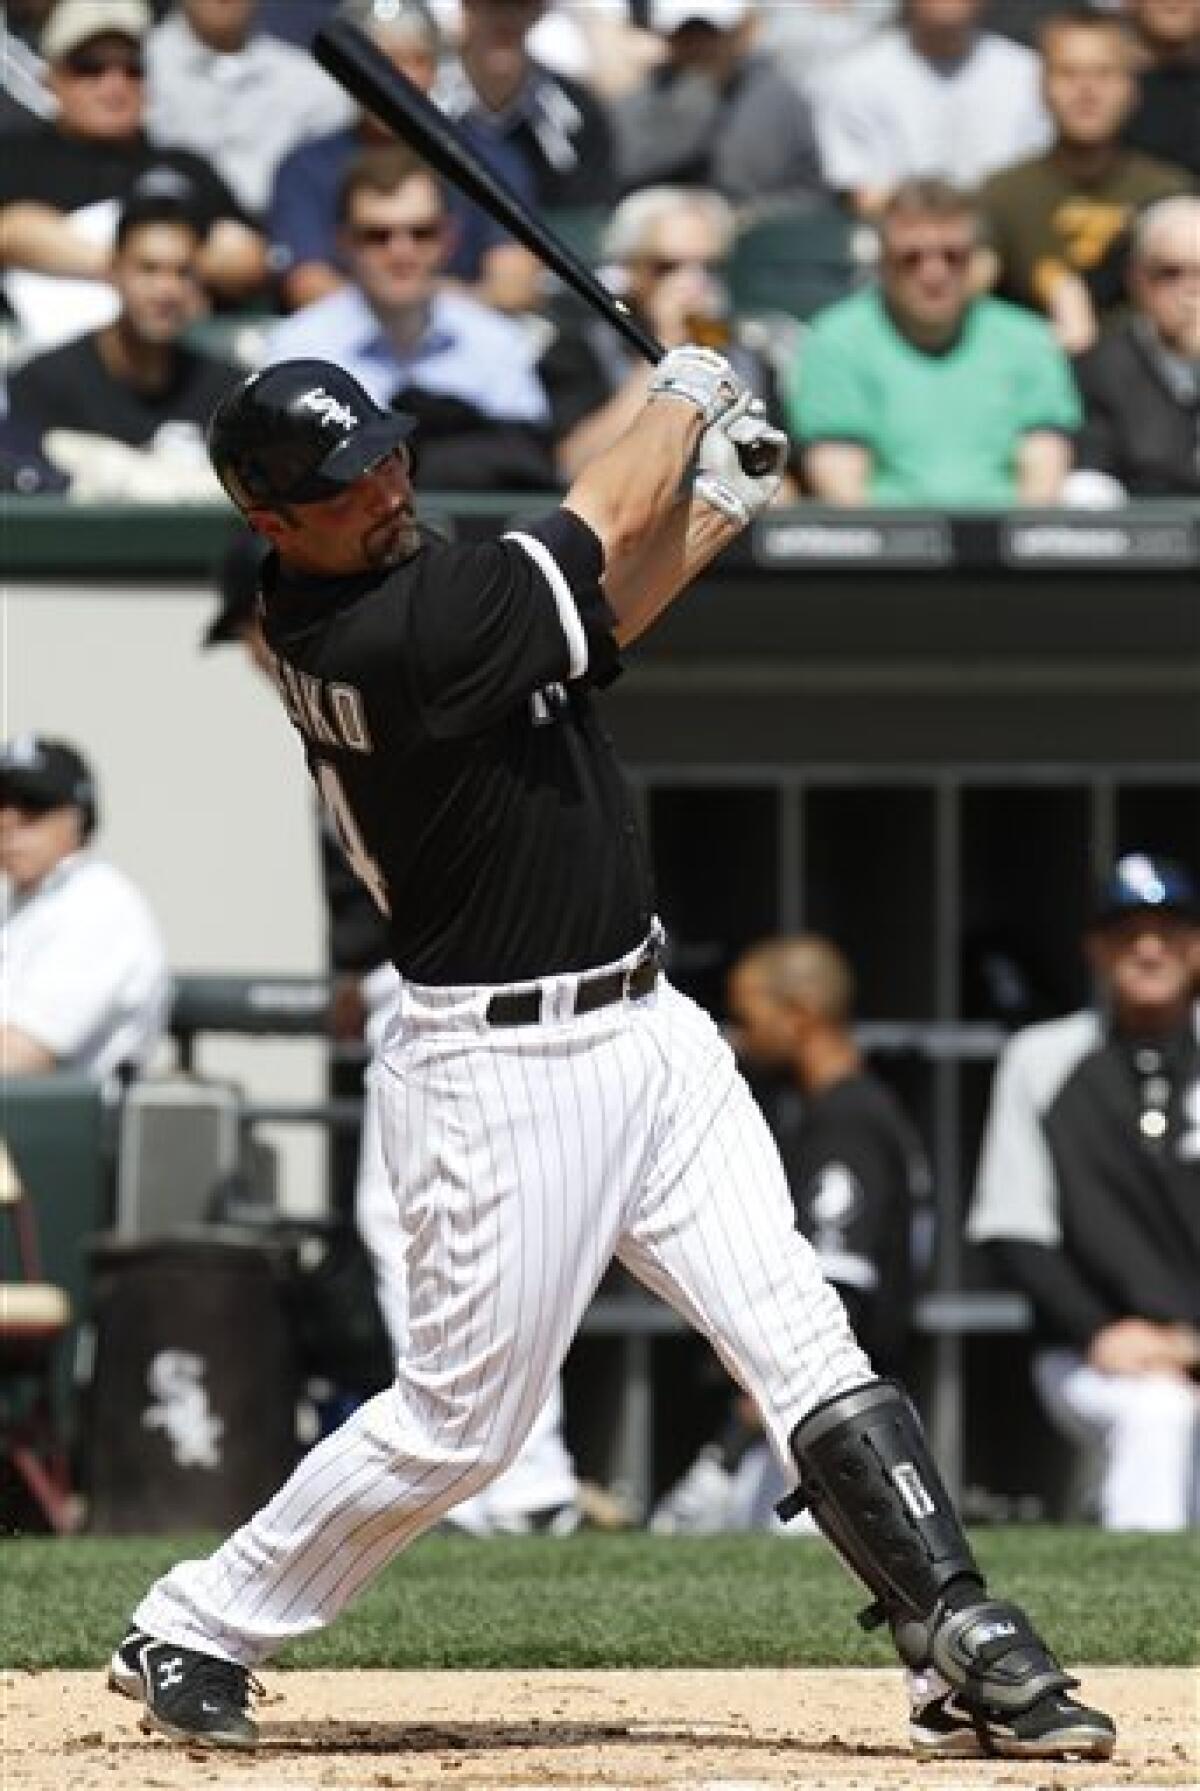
0,1526,1200,1667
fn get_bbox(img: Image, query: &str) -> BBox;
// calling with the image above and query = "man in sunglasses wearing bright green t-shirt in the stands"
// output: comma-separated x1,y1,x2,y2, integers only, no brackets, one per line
788,179,1080,509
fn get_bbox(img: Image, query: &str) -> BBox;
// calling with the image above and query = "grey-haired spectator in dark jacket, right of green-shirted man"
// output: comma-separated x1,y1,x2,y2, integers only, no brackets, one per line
1075,193,1200,501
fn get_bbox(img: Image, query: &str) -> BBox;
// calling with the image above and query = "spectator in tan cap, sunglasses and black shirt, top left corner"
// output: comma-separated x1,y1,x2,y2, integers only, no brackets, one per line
0,0,267,349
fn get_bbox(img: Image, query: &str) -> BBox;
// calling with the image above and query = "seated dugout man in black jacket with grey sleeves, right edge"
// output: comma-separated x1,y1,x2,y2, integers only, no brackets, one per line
967,853,1200,1530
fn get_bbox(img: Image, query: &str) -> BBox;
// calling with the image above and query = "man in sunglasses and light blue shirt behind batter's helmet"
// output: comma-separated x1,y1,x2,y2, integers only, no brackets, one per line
265,143,555,491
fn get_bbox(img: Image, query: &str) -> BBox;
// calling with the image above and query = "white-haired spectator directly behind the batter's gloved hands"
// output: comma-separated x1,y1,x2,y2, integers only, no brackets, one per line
539,186,799,494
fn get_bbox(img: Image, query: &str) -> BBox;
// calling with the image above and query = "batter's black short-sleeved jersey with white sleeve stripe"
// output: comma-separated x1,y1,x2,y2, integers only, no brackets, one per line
263,510,652,983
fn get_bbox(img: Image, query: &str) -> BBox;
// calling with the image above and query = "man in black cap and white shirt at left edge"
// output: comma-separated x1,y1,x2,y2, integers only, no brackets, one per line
0,734,168,1080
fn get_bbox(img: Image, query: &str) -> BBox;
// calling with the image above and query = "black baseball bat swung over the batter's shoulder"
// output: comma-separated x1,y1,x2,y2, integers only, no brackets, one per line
312,18,780,473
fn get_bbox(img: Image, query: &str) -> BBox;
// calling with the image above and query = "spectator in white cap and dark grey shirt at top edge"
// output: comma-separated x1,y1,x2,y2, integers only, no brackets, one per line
613,0,820,204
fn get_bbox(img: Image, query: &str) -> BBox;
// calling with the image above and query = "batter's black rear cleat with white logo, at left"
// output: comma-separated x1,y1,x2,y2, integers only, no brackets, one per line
107,1628,261,1748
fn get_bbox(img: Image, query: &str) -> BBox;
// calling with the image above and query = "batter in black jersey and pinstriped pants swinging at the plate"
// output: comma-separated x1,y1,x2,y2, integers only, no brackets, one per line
109,346,1114,1757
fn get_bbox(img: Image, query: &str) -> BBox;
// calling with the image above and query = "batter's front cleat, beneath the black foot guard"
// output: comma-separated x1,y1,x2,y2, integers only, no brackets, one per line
908,1691,1116,1761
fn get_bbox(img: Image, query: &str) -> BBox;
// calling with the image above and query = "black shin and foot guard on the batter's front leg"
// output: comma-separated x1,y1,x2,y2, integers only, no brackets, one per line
777,1381,1076,1710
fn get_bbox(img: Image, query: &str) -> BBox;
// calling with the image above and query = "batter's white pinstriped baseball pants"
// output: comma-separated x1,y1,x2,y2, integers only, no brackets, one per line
134,953,872,1666
